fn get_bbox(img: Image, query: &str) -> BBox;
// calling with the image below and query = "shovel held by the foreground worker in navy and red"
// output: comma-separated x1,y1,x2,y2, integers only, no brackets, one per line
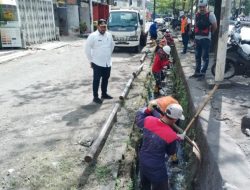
154,106,201,161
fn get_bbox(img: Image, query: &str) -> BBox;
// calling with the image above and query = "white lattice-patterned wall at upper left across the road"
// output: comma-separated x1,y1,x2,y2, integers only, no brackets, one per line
17,0,56,44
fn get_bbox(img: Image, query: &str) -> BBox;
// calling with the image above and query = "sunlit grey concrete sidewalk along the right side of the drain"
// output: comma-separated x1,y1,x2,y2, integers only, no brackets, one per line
177,42,250,190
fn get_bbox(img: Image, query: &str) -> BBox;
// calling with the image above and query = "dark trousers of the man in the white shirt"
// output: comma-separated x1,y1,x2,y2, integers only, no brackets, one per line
92,63,111,98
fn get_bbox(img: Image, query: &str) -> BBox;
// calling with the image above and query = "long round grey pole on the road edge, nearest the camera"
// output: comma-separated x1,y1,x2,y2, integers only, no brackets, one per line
84,103,121,162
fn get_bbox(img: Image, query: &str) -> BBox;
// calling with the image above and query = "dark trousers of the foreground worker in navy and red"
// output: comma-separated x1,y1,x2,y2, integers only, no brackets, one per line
141,174,168,190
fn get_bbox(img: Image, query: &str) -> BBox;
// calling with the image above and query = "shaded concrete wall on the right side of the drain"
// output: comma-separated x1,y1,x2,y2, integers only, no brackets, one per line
172,45,223,190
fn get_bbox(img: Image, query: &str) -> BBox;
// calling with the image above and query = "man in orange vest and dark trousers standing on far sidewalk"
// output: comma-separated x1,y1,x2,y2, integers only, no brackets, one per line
181,14,191,54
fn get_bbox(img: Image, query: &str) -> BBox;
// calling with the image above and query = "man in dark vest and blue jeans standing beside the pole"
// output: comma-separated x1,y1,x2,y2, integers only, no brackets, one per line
191,0,217,79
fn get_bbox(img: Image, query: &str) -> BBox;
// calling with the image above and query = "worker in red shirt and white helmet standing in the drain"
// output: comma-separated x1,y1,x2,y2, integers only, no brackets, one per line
152,45,171,94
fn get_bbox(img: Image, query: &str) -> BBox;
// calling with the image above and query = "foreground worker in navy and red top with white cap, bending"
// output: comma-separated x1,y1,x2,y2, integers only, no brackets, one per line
136,100,185,190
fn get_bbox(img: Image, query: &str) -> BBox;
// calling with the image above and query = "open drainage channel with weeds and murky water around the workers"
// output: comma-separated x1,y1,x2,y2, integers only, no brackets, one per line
116,48,199,190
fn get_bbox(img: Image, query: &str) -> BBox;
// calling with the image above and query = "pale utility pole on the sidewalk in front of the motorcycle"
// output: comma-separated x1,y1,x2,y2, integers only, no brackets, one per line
215,0,232,82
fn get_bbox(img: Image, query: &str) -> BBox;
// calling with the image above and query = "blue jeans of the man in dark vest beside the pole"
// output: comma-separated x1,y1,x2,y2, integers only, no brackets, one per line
195,38,210,74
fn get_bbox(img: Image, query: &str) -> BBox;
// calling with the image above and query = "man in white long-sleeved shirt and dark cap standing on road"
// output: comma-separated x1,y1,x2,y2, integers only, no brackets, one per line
85,19,114,104
